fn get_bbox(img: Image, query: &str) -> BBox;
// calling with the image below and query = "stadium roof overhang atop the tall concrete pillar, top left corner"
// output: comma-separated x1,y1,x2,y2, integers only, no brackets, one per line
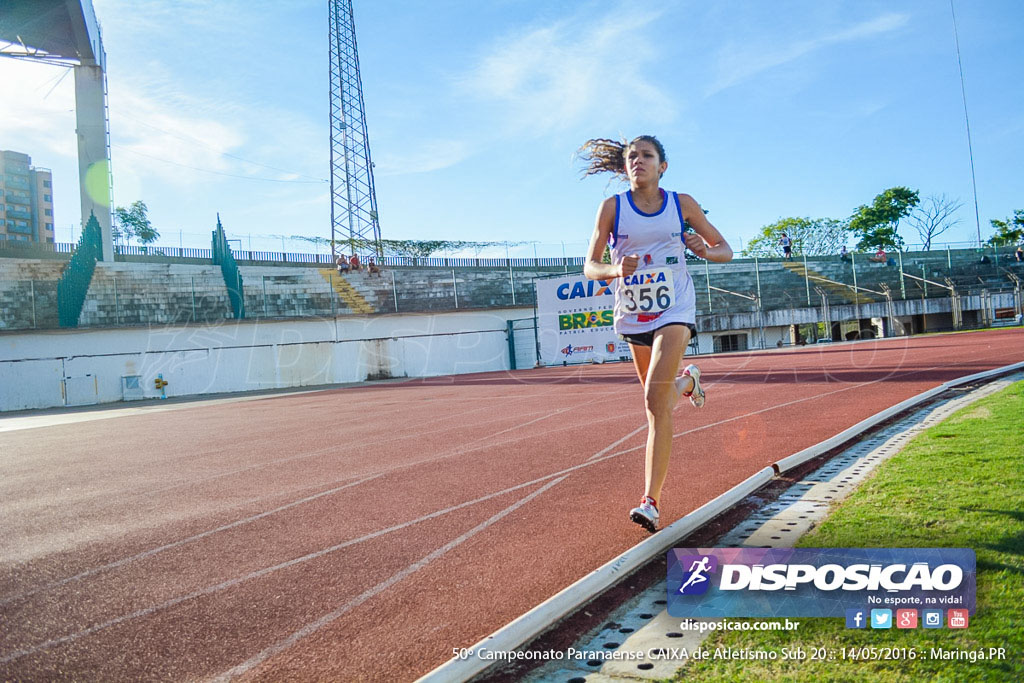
0,0,103,67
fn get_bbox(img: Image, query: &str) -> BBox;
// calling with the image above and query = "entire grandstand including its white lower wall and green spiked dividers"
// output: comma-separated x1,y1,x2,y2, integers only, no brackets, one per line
0,237,1024,411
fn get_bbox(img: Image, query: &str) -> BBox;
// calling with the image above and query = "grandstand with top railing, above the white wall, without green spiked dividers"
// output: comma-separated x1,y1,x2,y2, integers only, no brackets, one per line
0,244,1024,335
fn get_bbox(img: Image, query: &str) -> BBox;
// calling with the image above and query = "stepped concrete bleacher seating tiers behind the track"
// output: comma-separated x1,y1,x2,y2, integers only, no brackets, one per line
0,249,1024,330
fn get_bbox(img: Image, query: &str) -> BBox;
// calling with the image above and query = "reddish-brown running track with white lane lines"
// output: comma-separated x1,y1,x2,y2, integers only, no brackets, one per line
0,330,1024,681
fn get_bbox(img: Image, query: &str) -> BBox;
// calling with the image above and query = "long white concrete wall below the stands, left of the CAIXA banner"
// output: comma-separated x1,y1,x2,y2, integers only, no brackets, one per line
0,308,532,411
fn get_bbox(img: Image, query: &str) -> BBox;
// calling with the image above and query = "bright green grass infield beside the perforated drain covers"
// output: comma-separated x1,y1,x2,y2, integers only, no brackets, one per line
674,382,1024,681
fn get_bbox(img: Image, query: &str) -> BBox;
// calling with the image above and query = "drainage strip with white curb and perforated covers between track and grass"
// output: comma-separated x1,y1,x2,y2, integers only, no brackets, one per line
420,362,1024,683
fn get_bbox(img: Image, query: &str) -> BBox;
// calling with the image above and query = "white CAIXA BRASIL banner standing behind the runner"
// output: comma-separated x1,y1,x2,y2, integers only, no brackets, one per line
535,273,630,366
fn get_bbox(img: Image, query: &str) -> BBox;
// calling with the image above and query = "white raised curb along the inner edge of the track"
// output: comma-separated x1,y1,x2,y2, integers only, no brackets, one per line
417,362,1024,683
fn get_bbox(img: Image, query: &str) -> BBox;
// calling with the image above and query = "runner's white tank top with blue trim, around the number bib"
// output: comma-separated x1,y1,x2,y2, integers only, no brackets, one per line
608,189,696,334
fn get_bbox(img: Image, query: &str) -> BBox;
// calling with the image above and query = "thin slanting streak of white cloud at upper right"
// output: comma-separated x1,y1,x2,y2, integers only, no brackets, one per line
705,12,909,97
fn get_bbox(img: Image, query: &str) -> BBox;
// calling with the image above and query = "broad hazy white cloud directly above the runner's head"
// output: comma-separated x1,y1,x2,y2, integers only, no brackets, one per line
377,5,676,176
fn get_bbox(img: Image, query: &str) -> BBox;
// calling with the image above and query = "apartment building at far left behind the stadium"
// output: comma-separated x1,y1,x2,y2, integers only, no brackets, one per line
0,150,53,243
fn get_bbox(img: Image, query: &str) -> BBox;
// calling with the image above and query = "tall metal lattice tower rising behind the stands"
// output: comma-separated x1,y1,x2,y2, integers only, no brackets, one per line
329,0,382,257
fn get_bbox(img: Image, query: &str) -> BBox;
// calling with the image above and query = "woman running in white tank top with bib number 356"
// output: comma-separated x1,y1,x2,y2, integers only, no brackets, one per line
580,135,732,532
